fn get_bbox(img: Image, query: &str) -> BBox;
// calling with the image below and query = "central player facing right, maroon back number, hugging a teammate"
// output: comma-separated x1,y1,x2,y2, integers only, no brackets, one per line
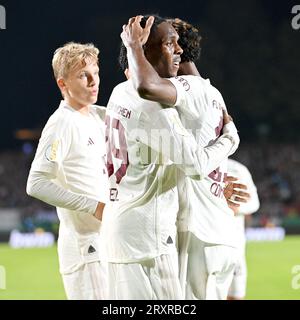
102,16,239,299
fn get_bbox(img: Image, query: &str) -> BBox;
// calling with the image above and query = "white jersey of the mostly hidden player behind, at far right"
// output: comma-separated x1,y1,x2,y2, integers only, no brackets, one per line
228,159,260,251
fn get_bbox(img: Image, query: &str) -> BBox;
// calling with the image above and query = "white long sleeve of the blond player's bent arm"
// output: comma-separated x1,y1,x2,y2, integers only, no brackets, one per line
26,114,98,214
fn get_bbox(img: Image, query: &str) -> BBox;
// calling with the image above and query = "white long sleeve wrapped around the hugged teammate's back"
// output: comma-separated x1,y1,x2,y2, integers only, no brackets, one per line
140,108,237,179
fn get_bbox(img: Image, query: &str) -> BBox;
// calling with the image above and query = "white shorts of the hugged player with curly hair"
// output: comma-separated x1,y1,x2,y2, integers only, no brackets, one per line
178,232,237,300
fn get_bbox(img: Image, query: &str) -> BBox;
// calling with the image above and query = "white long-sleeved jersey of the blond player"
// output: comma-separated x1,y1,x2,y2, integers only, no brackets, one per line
28,101,108,274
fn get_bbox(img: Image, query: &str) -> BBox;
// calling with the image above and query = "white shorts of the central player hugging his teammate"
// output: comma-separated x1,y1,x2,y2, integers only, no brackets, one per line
108,253,183,300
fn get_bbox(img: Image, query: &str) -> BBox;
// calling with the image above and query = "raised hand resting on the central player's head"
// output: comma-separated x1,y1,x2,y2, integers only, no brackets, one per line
121,16,154,48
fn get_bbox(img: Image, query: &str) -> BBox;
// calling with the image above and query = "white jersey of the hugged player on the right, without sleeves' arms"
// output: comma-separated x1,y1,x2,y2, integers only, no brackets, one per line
170,76,240,246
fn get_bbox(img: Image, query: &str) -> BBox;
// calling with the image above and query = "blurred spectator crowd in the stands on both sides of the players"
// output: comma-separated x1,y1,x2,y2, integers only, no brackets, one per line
0,143,300,231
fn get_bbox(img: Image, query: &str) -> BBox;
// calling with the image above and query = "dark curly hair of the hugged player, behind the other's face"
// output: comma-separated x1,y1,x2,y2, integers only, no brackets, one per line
168,18,201,62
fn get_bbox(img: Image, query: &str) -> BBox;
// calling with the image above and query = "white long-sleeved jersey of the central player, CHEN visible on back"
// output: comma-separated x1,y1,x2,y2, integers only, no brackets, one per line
102,80,237,263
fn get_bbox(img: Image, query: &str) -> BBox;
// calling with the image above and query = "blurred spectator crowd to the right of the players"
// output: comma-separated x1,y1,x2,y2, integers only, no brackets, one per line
234,143,300,232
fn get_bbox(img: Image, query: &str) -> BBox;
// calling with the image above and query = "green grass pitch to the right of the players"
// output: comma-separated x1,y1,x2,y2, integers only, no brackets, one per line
247,236,300,300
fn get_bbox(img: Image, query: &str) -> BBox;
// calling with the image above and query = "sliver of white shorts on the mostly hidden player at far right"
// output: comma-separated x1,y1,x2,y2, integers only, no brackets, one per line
228,250,247,299
